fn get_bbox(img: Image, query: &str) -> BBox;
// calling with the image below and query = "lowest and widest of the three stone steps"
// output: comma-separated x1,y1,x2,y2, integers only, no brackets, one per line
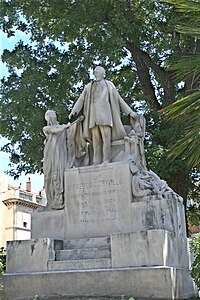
48,258,111,271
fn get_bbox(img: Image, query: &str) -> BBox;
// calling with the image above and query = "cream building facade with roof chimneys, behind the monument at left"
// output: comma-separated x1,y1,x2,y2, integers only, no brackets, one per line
0,174,46,248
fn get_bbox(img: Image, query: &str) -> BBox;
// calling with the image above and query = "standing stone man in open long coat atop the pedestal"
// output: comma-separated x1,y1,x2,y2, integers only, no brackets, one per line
69,66,137,165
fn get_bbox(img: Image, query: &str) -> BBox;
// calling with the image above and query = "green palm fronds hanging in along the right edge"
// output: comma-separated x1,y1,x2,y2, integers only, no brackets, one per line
163,0,200,167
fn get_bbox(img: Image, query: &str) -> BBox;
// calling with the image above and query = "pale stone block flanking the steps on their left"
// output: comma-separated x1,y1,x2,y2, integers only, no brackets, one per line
6,238,63,273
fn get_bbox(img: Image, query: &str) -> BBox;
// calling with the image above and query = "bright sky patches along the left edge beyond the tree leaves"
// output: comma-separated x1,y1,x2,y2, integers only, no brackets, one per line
0,30,44,192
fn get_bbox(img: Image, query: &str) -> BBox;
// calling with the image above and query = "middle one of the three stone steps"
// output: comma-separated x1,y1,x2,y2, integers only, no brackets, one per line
56,247,111,261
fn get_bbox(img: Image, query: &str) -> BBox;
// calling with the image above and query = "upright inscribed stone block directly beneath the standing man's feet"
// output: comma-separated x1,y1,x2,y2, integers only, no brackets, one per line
65,163,132,238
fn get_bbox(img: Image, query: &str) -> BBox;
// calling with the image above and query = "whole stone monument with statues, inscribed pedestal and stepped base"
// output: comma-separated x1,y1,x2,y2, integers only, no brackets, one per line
1,67,196,299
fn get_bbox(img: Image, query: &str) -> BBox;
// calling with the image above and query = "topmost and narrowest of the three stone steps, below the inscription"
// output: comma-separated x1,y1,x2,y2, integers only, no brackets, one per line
63,236,110,249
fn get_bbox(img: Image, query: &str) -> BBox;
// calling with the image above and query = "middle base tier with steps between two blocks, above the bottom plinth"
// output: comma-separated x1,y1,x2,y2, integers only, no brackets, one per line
6,230,190,273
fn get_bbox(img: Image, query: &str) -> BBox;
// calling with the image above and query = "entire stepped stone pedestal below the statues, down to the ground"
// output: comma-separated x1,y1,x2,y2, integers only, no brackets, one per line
3,162,196,300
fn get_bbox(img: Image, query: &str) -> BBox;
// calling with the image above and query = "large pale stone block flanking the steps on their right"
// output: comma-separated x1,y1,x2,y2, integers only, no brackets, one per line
111,230,189,268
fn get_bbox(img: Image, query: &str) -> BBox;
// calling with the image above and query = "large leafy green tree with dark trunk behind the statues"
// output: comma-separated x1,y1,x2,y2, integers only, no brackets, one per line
0,0,197,209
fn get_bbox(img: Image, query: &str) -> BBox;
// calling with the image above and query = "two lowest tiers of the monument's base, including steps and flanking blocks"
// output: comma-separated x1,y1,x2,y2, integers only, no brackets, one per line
2,230,198,300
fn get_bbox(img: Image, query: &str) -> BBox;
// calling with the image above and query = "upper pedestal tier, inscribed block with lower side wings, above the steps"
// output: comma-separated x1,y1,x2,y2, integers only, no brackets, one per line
32,162,186,240
